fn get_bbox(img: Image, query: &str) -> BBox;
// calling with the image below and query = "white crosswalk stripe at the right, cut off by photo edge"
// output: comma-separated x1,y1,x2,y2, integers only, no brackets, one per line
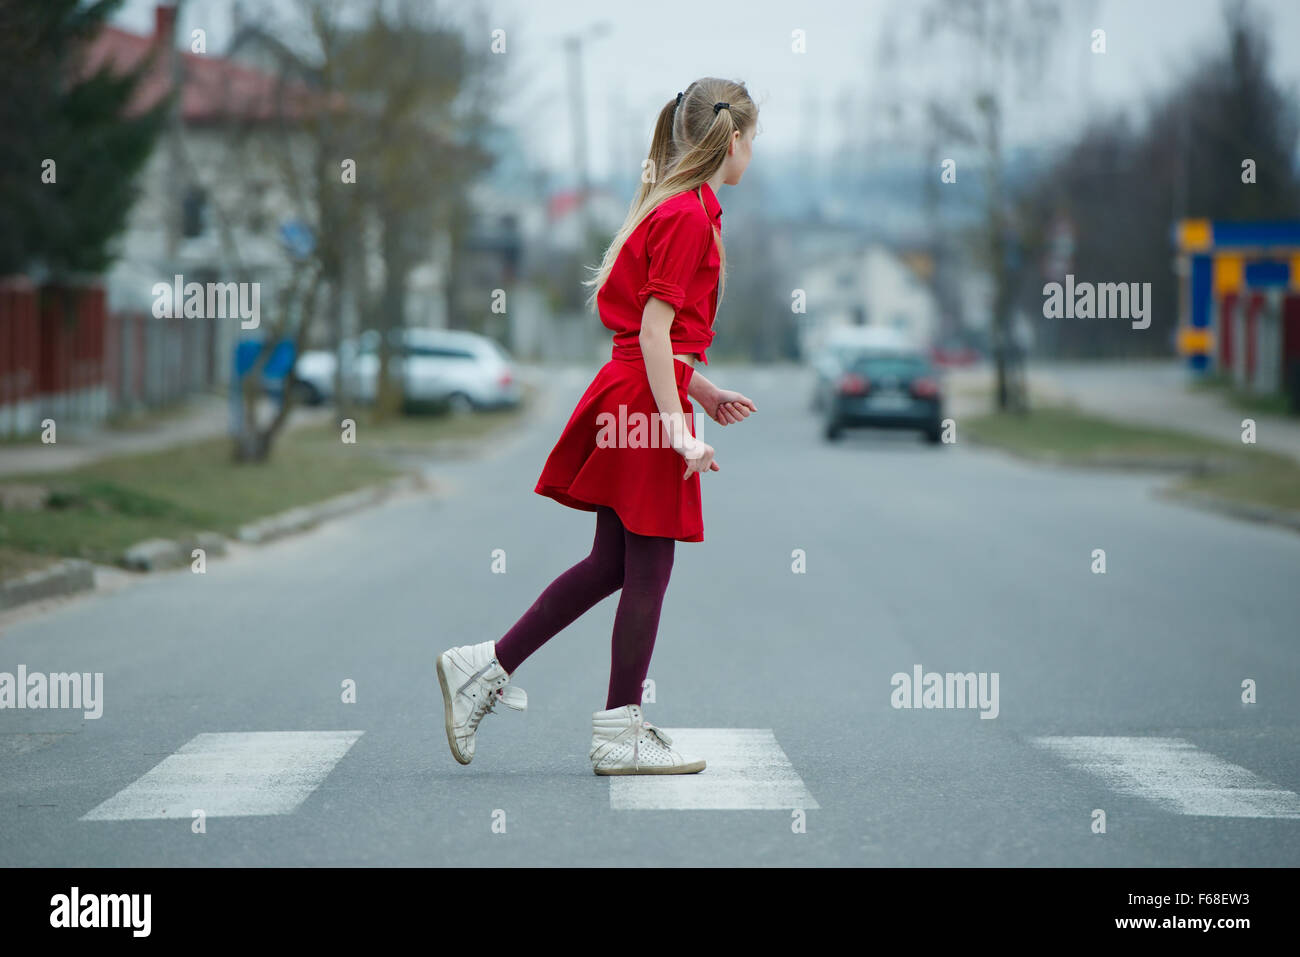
1031,737,1300,818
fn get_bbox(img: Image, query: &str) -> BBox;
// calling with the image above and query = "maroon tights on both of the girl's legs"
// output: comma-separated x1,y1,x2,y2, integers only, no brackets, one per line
497,506,676,710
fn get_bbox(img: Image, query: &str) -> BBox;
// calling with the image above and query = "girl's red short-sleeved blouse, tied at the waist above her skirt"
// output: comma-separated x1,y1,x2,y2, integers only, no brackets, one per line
595,182,723,365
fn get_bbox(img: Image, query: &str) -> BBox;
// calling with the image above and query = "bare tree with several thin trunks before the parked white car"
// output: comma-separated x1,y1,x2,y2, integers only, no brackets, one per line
222,0,490,460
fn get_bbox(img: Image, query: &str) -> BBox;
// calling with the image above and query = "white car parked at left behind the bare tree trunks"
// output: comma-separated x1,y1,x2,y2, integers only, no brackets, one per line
295,329,523,412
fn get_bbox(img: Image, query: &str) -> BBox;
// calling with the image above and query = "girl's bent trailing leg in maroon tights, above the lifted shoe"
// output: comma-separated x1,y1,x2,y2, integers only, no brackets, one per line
497,506,624,675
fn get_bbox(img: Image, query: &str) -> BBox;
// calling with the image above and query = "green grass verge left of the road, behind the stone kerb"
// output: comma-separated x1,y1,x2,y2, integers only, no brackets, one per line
0,392,521,567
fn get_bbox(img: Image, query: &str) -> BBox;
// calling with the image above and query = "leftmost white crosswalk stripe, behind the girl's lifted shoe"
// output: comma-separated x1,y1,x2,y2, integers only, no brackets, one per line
82,731,364,820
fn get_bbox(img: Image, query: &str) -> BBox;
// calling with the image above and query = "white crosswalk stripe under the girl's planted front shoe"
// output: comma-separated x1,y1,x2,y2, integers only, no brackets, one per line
610,728,820,810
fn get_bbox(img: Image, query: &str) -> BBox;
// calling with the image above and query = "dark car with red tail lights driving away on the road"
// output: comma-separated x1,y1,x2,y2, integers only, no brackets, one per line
823,350,944,443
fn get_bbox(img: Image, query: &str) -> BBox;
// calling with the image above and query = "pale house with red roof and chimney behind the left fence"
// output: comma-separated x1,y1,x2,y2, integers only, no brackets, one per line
83,3,341,406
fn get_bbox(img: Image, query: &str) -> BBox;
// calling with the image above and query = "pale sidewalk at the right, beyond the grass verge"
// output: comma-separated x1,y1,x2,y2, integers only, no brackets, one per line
950,359,1300,462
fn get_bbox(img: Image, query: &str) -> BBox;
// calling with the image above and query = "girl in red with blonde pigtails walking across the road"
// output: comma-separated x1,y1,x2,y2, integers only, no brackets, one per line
438,77,758,775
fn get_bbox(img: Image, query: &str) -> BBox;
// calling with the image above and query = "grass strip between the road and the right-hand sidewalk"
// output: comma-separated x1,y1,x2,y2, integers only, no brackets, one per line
959,406,1300,512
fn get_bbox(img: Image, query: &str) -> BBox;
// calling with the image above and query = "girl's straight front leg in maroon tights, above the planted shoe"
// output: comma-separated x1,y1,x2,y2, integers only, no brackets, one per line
605,520,676,710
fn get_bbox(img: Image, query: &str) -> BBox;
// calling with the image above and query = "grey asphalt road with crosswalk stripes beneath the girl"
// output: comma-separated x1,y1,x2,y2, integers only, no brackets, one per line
0,365,1300,866
